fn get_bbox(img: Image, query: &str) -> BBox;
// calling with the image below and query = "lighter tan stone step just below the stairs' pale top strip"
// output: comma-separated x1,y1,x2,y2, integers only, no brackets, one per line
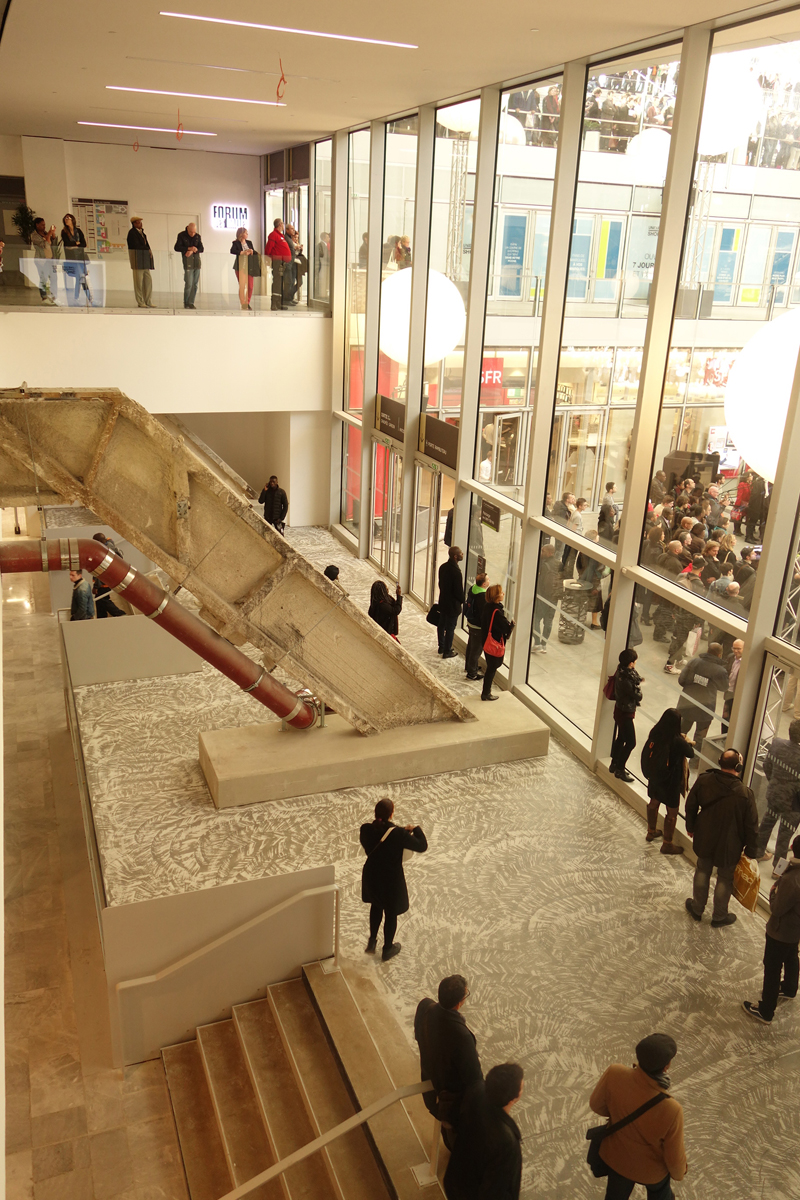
303,962,443,1200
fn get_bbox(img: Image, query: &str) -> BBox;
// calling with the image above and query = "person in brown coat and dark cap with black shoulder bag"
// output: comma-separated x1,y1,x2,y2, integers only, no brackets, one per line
589,1033,687,1200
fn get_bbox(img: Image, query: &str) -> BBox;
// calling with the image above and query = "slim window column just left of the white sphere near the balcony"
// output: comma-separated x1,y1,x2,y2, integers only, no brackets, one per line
359,121,386,558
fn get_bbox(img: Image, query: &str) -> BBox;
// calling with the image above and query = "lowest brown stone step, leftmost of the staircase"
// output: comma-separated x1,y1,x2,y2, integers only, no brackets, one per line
161,1042,233,1200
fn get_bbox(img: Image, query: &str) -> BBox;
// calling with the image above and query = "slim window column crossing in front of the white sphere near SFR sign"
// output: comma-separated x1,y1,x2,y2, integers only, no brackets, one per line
398,104,437,592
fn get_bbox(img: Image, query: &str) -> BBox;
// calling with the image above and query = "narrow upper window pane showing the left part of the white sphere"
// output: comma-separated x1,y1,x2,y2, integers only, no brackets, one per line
378,114,420,402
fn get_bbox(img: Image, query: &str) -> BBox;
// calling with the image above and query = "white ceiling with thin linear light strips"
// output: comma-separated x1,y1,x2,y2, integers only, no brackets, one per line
0,0,796,154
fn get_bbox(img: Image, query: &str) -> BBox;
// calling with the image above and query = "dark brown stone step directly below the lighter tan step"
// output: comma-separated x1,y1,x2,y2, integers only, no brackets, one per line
267,979,391,1200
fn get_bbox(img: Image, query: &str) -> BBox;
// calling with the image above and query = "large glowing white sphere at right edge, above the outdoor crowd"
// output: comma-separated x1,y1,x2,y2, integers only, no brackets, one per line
724,312,800,484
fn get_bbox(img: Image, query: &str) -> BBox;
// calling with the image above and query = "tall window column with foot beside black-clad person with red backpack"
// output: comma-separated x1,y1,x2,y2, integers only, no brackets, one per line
593,25,712,762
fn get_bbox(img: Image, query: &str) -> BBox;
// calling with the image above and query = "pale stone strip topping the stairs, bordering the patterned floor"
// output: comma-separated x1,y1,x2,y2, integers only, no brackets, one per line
342,964,441,1161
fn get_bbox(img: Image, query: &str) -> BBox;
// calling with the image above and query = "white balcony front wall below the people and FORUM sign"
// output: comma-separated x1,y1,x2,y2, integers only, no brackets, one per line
0,308,332,413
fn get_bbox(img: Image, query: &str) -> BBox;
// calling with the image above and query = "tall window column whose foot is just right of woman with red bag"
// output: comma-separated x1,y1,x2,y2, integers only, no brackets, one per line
509,59,587,686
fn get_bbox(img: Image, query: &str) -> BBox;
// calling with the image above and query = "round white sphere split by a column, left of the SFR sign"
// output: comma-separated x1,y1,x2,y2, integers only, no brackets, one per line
378,270,467,367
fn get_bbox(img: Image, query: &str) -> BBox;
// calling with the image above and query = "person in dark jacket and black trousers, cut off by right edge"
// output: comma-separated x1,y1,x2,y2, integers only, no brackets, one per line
742,838,800,1025
